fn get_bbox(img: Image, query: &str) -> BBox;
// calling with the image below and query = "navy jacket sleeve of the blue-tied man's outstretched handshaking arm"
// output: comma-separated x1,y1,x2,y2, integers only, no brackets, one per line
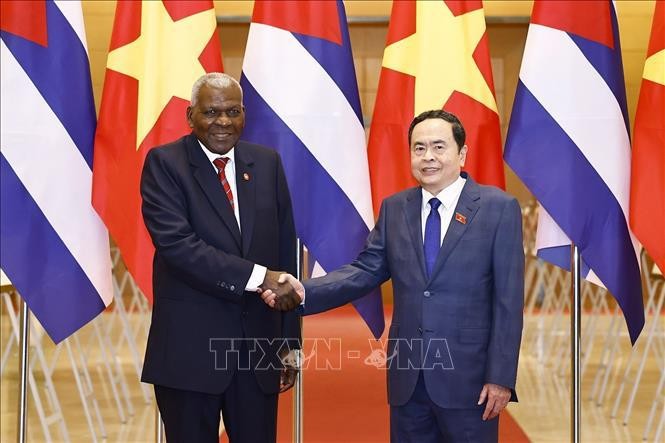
303,202,390,315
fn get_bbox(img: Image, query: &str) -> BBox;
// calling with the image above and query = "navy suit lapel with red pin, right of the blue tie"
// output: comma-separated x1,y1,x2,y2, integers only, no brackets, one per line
432,175,480,276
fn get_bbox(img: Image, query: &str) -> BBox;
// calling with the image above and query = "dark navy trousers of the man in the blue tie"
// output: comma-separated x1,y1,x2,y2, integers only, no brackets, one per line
390,371,499,443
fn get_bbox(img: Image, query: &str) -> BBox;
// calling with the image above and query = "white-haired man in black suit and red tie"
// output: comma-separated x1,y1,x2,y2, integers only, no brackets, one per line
141,73,300,443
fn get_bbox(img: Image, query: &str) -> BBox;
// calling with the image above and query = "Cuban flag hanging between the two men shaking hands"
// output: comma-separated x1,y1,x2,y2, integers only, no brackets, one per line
241,1,384,338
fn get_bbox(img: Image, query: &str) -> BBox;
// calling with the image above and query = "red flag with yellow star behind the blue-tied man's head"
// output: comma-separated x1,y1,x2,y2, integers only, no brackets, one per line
368,0,505,213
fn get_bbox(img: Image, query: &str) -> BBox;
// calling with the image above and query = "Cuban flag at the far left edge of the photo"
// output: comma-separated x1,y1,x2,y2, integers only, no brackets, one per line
0,1,113,343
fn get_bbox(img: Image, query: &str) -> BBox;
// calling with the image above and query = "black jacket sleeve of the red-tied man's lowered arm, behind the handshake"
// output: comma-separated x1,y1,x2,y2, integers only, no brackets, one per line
277,156,302,349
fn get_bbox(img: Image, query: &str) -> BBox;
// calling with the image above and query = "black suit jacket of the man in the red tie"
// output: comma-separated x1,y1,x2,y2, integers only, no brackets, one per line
141,134,300,394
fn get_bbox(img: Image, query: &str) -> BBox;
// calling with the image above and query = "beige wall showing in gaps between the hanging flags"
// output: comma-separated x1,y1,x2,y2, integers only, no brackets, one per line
83,0,655,202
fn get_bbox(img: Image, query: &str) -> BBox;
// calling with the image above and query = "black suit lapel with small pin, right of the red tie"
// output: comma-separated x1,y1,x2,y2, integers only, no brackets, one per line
235,142,256,256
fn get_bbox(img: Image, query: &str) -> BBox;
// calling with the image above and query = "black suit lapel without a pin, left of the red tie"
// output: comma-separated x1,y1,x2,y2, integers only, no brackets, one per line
187,135,241,247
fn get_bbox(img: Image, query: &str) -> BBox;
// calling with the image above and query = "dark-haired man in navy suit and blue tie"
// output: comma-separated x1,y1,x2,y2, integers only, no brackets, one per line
262,110,524,443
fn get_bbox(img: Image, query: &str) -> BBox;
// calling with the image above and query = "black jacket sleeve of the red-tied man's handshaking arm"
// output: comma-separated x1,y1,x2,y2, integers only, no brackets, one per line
141,149,254,302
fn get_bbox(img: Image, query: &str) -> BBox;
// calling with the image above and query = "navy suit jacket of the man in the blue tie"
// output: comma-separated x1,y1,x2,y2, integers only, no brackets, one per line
304,173,524,408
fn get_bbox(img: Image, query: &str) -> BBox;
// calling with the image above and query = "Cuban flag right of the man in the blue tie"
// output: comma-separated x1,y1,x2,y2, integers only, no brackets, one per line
504,0,644,343
